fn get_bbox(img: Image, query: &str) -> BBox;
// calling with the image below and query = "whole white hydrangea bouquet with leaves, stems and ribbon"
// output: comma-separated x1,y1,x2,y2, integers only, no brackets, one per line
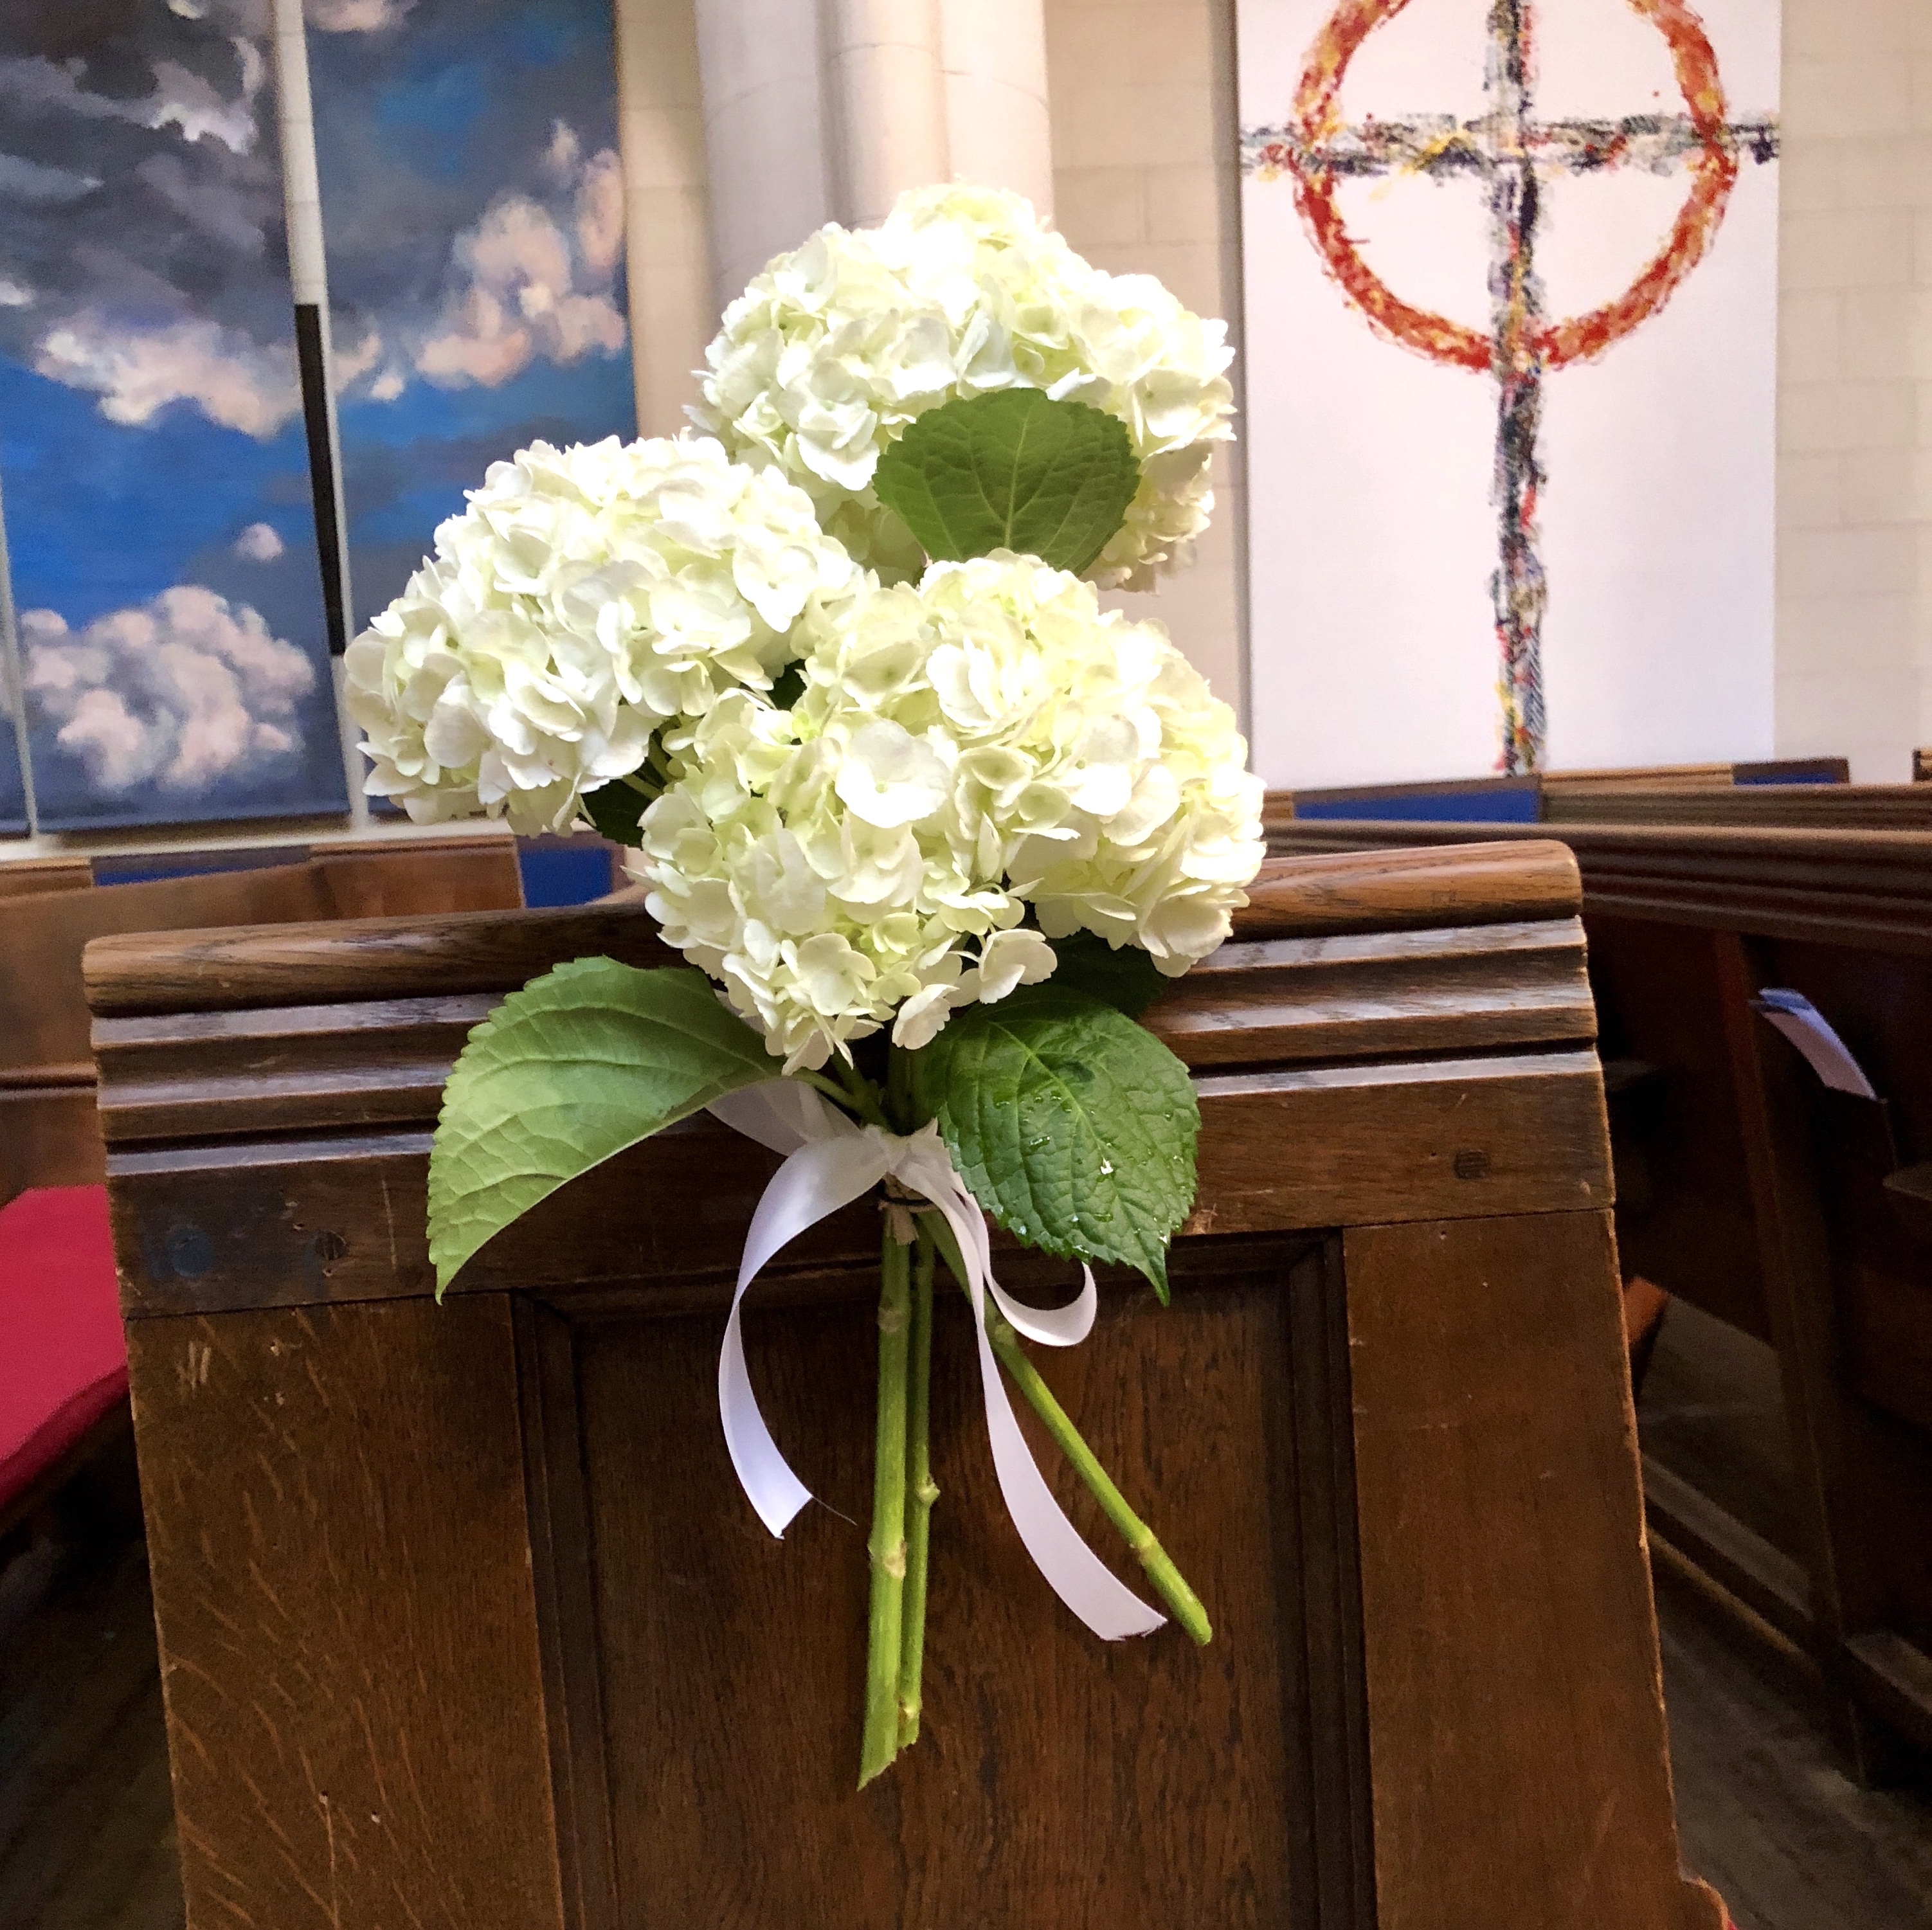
348,187,1263,1783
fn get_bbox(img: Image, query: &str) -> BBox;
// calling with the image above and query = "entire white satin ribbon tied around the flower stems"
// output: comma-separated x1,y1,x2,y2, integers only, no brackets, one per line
711,1078,1167,1642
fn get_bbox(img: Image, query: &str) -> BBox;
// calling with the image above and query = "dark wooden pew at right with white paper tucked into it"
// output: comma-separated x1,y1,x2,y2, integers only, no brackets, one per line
1273,823,1932,1776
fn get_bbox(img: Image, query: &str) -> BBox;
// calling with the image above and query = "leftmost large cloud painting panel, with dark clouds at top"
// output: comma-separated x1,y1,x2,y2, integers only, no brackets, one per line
0,0,346,829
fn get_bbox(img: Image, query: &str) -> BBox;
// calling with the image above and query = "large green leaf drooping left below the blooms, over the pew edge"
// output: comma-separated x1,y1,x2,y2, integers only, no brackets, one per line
429,958,777,1294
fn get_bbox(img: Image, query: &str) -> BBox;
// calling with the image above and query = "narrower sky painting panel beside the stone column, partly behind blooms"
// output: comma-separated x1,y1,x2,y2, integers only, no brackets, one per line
309,0,636,626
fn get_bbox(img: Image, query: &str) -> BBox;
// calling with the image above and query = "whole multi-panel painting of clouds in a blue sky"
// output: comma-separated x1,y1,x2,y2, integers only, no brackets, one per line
0,0,636,834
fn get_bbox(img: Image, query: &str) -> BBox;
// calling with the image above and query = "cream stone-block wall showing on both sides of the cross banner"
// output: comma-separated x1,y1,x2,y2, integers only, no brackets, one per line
1045,0,1932,782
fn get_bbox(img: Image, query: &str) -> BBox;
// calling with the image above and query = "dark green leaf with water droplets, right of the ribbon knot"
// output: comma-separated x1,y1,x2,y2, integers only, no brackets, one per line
912,980,1200,1300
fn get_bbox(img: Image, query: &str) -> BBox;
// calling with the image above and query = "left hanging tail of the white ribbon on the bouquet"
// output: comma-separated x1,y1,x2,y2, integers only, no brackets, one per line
719,1134,890,1536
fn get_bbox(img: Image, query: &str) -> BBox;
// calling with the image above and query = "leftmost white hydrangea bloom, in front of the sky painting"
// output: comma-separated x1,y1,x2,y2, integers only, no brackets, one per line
348,433,858,831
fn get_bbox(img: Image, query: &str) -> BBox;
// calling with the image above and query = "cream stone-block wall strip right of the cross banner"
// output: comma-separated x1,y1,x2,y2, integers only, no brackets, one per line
1778,0,1932,784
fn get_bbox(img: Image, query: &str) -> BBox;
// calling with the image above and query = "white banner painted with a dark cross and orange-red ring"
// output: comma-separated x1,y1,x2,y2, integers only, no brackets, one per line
1238,0,1780,786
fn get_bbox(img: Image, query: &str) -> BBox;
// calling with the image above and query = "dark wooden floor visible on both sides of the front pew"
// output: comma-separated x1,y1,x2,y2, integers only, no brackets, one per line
0,1344,1932,1930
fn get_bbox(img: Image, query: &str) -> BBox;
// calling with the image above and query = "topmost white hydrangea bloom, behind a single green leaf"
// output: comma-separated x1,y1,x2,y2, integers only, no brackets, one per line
692,187,1234,590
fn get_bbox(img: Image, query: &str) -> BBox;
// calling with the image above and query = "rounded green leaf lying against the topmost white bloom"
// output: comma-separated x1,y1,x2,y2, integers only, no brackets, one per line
873,388,1140,572
